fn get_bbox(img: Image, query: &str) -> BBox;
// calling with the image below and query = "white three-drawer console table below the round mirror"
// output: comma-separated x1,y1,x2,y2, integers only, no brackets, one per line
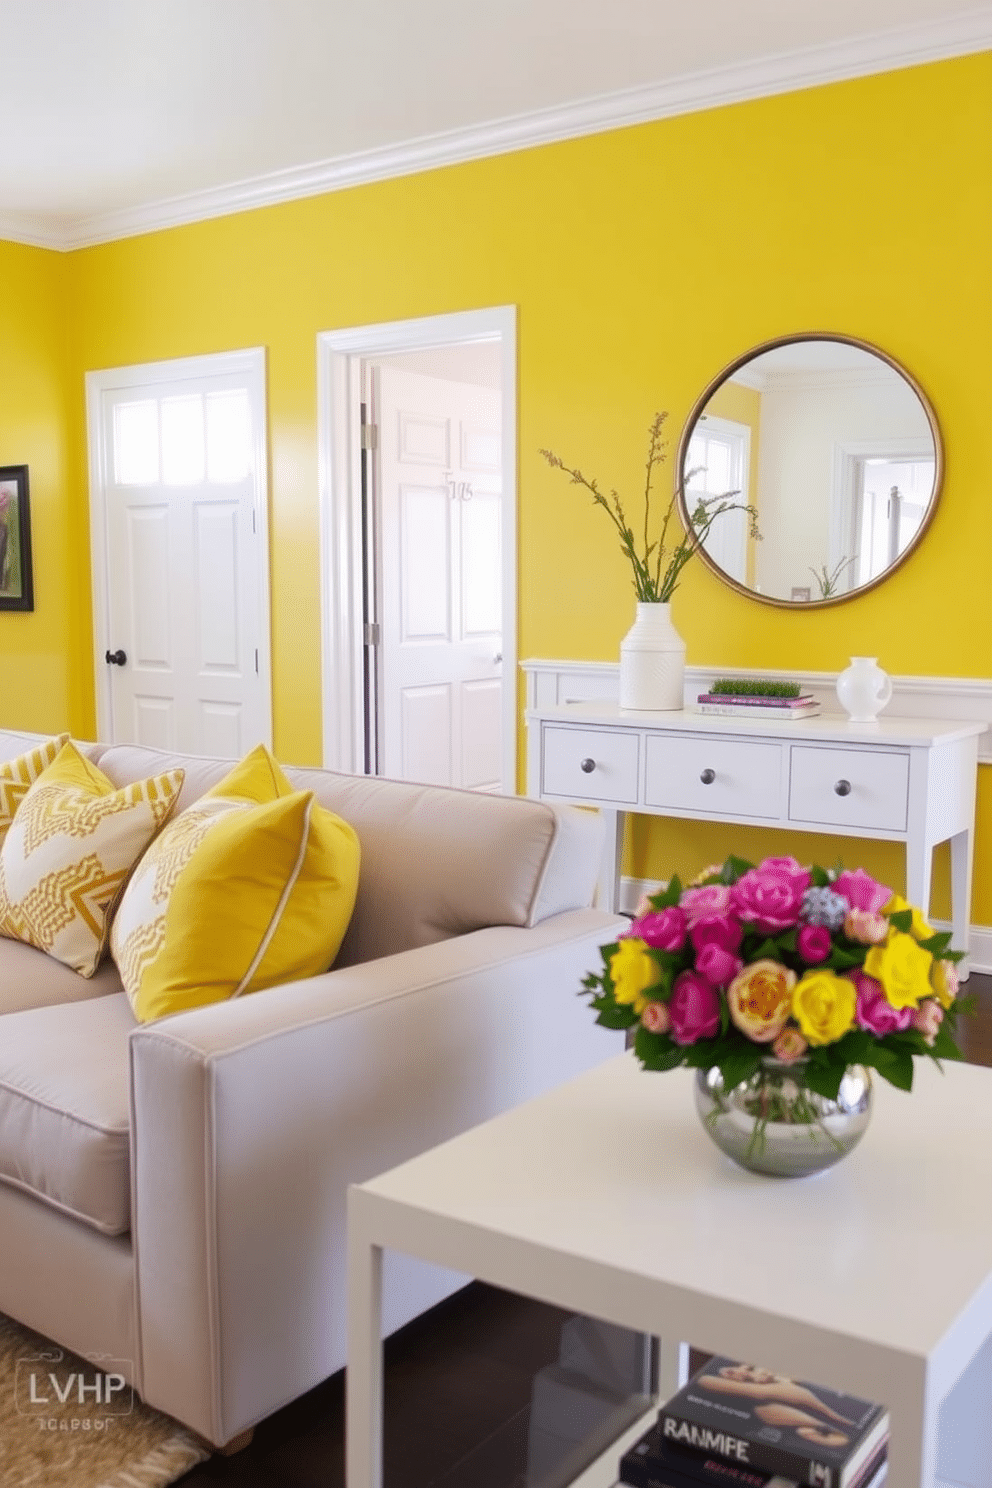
526,702,986,972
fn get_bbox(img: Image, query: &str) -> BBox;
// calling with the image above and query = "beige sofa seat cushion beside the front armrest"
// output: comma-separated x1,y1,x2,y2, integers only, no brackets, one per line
0,992,135,1235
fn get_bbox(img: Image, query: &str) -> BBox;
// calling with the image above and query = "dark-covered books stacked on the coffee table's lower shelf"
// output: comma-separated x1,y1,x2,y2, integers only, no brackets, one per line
620,1359,889,1488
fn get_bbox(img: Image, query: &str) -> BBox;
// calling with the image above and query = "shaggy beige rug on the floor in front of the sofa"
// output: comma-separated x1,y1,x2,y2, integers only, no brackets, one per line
0,1314,210,1488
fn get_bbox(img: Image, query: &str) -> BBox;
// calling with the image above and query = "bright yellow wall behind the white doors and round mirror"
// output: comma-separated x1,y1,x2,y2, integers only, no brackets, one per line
7,54,992,924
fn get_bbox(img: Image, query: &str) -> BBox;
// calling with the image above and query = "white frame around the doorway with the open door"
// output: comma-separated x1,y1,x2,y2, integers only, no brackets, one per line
317,305,518,795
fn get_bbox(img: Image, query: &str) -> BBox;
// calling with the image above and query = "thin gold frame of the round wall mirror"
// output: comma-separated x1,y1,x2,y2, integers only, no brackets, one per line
675,330,944,610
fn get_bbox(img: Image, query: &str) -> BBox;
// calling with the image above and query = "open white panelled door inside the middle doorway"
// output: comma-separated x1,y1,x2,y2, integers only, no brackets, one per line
373,366,503,790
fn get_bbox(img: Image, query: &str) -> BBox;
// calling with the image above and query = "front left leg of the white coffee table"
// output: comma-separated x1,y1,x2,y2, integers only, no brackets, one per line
345,1189,382,1488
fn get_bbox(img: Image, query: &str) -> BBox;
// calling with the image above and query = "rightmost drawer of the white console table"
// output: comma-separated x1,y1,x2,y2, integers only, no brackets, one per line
788,744,909,832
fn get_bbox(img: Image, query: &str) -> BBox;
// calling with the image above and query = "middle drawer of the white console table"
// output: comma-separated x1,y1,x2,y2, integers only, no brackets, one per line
644,735,782,818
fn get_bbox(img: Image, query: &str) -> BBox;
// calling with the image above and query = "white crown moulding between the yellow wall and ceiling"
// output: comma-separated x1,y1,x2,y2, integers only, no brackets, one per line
9,4,992,251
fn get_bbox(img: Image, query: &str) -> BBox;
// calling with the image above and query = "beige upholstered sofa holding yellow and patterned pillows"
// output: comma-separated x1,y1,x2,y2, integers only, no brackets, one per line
0,731,623,1445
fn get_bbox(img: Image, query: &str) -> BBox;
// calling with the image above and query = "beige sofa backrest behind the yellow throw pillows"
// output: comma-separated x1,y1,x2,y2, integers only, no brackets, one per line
100,744,602,966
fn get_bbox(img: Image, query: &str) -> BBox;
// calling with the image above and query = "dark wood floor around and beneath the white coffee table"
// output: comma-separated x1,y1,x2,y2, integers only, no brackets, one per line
181,975,992,1488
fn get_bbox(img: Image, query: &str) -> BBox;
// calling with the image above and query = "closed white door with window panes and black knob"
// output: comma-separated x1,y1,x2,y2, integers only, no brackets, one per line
88,353,272,756
